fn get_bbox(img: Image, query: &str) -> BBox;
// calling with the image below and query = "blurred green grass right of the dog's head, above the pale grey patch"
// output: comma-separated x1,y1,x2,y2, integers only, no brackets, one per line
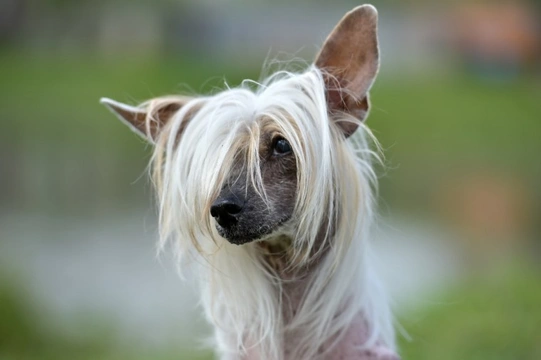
368,72,541,216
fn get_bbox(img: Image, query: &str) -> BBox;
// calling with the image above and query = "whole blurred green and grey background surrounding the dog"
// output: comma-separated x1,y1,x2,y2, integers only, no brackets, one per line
0,0,541,360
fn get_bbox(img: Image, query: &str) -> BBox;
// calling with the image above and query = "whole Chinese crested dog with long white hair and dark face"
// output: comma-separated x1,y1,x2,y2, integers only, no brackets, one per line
101,5,399,360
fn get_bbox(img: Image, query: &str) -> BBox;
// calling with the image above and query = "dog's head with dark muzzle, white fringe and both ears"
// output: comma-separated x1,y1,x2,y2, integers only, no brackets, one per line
102,5,379,253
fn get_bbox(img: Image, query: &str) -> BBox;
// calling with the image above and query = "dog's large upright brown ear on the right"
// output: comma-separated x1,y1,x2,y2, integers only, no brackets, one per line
315,5,379,137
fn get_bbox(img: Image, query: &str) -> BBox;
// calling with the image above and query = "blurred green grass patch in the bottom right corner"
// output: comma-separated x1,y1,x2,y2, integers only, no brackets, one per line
401,265,541,360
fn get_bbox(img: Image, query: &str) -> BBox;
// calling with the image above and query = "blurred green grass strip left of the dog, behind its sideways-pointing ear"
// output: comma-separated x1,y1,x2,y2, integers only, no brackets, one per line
0,53,258,151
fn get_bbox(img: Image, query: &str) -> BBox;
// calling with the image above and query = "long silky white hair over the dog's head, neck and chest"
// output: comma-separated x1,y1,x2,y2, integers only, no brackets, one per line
147,66,394,360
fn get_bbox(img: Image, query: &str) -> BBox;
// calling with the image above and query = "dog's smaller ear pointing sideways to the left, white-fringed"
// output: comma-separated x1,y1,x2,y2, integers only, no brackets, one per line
100,96,191,143
